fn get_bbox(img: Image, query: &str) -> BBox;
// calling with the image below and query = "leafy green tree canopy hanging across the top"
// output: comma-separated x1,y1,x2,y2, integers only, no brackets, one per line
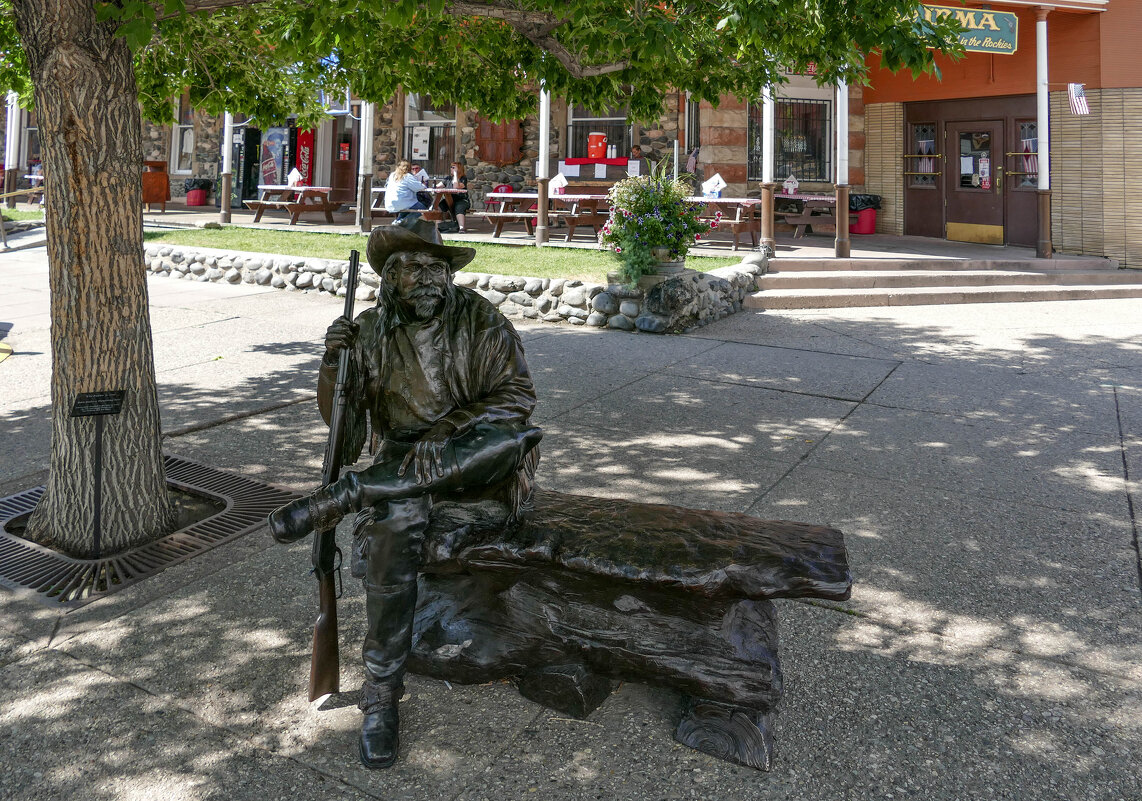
0,0,959,122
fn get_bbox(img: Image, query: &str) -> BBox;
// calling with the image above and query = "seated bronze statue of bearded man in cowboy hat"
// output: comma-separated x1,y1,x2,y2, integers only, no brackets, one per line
270,224,541,768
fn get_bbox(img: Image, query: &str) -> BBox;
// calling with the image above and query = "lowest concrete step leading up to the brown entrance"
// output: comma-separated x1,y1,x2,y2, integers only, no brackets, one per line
742,282,1142,309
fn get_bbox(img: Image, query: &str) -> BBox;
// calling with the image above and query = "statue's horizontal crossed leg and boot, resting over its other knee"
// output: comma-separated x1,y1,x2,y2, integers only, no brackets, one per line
270,425,542,543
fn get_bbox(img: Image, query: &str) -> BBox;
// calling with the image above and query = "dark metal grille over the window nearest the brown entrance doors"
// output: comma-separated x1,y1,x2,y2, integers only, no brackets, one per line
747,98,833,182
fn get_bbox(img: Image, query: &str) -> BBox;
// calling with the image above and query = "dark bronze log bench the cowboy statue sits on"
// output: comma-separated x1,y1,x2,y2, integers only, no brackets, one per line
409,490,852,770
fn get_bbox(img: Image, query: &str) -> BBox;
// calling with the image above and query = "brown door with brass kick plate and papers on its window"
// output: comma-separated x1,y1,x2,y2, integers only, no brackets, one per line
943,120,1006,245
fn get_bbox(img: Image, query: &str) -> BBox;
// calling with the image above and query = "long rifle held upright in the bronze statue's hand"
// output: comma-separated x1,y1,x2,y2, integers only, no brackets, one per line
309,250,361,700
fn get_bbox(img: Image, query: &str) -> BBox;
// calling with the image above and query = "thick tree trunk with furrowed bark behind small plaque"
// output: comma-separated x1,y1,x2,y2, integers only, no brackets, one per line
15,0,174,556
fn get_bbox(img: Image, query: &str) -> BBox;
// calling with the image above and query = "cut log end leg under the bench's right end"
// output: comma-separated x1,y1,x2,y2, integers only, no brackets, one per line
674,697,773,770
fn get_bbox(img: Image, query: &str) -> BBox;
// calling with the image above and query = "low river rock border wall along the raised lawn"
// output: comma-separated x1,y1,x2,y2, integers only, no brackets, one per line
145,245,769,334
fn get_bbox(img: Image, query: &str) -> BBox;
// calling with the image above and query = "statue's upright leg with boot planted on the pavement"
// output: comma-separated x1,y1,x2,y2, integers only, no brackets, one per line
360,497,432,768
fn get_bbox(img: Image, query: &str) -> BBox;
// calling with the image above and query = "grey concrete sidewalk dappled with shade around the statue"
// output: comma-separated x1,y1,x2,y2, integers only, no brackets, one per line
0,245,1142,801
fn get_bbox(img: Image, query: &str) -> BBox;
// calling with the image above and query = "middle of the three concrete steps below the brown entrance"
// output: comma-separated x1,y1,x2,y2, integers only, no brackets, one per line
757,270,1142,290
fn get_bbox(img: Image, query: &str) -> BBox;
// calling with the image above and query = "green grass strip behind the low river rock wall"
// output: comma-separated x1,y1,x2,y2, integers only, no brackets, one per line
143,226,741,283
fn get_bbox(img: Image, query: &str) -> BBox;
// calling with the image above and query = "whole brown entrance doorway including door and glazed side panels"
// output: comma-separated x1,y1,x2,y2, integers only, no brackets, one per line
903,97,1038,247
